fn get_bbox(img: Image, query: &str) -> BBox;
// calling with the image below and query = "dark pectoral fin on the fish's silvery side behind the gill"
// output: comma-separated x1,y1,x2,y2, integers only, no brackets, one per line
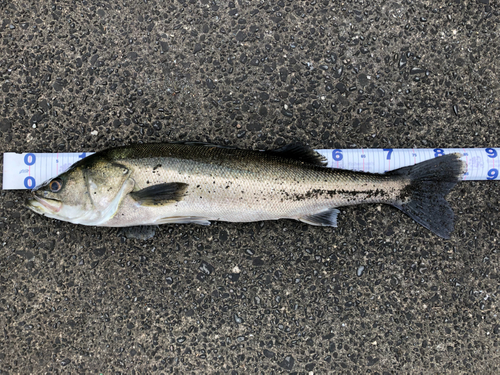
130,182,189,206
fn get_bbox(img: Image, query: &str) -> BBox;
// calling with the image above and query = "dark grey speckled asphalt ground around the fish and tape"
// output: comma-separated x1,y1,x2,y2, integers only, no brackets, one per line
0,0,500,374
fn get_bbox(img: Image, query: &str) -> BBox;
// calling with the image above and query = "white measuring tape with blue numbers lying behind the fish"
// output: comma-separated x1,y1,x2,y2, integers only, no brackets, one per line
2,148,500,190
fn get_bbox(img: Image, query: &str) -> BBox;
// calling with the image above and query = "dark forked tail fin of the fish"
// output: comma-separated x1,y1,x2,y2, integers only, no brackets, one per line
387,153,465,239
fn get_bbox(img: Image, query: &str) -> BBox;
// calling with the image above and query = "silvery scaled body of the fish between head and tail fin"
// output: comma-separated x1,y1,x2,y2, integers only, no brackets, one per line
101,144,405,226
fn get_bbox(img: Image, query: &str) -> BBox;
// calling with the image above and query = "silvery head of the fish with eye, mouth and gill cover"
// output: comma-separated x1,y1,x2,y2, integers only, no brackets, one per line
26,157,134,226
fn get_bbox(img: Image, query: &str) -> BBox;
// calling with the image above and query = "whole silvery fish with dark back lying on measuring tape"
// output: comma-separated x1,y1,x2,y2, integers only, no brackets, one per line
25,142,466,239
